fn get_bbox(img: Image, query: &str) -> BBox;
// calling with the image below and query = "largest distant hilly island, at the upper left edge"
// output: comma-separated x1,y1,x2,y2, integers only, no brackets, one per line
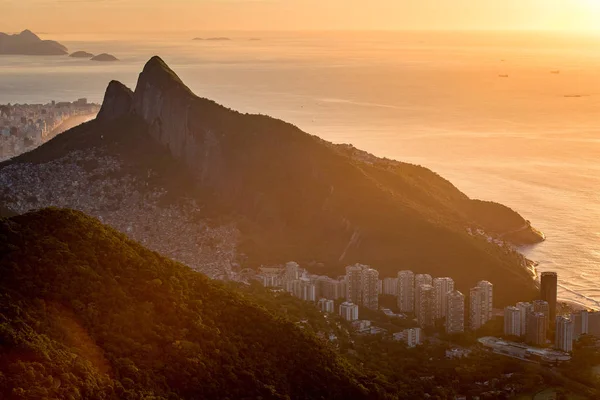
0,29,69,56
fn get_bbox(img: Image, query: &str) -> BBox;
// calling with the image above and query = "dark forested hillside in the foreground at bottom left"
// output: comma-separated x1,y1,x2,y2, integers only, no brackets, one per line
0,209,378,399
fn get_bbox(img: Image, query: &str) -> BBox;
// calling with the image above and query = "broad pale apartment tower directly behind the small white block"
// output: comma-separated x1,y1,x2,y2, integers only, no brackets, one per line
346,264,379,310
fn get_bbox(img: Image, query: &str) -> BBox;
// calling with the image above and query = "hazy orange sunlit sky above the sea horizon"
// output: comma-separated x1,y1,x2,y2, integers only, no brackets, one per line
0,0,600,32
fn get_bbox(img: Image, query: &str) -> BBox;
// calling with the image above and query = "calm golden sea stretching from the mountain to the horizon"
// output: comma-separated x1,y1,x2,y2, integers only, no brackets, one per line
0,32,600,308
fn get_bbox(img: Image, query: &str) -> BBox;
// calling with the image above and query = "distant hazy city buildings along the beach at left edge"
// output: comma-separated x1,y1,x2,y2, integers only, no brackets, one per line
0,99,100,160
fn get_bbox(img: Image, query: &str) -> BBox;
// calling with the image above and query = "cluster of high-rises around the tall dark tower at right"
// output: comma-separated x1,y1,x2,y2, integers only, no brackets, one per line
504,272,600,352
